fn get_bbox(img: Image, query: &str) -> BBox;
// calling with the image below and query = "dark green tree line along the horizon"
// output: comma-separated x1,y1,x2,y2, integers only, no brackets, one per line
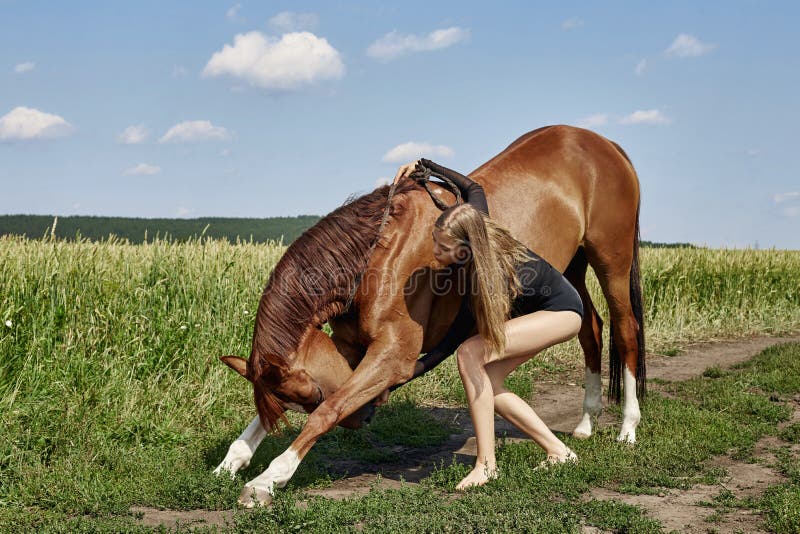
0,215,696,248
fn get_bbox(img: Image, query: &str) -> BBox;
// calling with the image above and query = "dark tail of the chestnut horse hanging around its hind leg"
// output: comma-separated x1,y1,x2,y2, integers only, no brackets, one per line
608,201,647,402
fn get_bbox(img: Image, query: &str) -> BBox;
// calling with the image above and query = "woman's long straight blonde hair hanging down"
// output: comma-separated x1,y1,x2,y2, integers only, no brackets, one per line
436,204,531,360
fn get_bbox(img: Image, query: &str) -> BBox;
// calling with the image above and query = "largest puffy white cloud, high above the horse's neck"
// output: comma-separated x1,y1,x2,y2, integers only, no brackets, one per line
203,31,344,90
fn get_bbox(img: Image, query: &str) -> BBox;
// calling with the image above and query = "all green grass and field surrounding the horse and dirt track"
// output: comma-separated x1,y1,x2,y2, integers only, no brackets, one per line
0,237,800,532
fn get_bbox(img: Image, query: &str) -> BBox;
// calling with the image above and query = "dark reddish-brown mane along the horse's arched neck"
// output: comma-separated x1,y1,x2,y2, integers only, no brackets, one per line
249,180,420,378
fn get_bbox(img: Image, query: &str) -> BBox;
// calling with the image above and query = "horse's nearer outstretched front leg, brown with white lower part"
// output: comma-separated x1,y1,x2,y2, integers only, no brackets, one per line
239,336,418,508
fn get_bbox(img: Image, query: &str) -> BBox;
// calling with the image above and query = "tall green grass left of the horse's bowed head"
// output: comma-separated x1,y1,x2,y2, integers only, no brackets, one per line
0,238,283,520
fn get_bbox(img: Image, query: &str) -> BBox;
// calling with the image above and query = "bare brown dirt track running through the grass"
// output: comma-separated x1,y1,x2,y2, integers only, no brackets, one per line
132,335,800,532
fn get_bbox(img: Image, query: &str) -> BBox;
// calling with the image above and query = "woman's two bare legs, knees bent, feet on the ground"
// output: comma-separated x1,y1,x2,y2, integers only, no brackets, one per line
456,311,581,489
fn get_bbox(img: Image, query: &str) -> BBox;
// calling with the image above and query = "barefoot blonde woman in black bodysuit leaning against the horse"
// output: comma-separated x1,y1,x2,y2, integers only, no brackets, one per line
394,159,583,490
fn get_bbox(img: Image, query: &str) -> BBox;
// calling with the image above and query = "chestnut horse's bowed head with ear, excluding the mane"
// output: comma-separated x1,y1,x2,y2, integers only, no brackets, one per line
220,328,374,430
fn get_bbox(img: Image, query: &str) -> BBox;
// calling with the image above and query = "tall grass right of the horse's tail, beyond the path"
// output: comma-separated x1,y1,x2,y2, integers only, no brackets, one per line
642,248,800,349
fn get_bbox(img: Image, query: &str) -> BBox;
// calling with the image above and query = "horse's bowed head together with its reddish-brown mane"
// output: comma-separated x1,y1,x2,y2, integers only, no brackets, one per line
216,181,422,436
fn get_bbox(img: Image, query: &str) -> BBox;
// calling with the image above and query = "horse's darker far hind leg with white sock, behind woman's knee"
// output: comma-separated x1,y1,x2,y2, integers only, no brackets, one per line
564,247,603,439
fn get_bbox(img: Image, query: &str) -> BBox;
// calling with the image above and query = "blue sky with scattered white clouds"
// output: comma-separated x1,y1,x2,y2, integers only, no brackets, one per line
0,0,800,249
